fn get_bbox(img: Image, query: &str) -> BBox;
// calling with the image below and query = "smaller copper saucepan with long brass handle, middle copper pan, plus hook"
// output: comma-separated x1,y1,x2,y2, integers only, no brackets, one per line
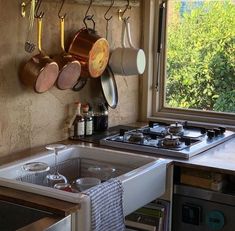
53,0,81,90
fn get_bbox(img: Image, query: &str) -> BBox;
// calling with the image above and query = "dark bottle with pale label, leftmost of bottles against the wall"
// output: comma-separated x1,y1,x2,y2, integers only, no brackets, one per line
73,103,85,138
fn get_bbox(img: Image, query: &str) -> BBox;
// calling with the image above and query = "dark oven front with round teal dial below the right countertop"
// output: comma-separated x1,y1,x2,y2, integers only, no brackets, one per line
172,185,235,231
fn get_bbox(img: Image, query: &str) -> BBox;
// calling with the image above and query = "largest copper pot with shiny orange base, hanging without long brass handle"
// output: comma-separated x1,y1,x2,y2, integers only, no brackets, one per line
68,28,109,78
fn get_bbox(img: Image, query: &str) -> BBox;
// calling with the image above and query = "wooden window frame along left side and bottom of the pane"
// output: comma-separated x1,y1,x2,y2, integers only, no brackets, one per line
140,0,235,129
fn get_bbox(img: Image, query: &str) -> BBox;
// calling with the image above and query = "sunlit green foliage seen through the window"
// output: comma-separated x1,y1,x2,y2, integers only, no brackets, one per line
164,0,235,113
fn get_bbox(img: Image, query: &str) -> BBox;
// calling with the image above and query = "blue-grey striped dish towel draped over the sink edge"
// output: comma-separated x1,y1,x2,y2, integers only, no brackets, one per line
83,178,125,231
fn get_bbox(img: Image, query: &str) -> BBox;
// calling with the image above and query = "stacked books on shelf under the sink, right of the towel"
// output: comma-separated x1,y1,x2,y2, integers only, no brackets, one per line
125,199,170,231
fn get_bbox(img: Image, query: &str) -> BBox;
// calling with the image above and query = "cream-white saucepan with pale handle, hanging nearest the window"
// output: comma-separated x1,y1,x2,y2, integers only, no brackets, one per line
109,18,146,76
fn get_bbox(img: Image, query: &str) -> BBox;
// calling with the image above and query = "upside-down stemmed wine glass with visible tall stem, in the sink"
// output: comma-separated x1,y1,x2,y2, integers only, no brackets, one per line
46,144,67,187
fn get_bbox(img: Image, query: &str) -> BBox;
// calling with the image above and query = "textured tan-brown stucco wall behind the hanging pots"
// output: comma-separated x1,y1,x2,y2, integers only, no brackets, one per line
0,0,141,156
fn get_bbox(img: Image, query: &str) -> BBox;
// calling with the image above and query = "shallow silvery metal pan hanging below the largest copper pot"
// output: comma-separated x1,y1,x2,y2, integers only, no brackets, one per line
100,66,118,109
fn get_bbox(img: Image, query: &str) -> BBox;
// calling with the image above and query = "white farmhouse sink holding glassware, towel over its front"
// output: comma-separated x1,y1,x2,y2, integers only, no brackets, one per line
0,145,169,231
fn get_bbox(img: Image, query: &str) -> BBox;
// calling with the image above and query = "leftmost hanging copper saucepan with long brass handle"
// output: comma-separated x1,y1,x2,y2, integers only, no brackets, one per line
20,17,59,93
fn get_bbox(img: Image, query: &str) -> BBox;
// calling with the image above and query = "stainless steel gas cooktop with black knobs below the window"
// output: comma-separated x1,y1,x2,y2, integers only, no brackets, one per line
100,122,235,159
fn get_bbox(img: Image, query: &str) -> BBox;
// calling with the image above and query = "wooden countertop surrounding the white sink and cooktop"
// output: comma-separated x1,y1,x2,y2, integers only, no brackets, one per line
0,132,235,216
